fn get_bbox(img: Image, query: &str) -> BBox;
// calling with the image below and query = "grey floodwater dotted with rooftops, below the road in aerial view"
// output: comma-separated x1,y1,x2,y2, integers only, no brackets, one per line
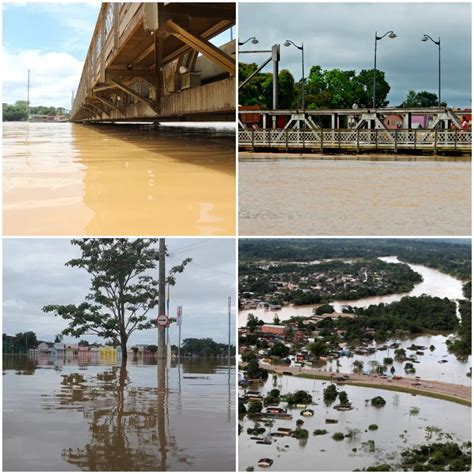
239,376,471,471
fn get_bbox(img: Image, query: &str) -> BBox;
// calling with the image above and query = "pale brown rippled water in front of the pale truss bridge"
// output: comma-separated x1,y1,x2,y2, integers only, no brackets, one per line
239,159,471,236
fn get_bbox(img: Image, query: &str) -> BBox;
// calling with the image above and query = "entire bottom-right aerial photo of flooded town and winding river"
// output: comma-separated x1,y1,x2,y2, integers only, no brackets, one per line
238,239,471,471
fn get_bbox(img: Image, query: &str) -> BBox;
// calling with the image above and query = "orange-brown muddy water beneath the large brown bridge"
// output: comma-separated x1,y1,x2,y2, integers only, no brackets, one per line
3,122,235,235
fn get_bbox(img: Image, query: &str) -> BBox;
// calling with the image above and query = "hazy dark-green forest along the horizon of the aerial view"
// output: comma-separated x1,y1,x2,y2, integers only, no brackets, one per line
239,239,471,281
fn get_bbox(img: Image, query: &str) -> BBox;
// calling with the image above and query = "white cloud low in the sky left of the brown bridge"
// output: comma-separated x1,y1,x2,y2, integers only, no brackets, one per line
2,49,83,109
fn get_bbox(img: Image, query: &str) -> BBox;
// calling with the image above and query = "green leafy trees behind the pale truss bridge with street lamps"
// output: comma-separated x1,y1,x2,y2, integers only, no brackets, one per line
239,63,445,110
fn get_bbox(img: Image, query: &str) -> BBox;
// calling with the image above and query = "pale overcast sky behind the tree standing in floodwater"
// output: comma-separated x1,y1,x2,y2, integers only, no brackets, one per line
3,239,235,344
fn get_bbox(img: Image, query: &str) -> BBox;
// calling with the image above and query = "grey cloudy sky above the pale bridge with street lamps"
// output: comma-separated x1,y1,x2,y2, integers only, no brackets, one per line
239,2,471,107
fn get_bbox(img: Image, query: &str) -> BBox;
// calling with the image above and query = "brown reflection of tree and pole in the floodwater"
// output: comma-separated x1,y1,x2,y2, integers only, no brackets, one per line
49,364,191,471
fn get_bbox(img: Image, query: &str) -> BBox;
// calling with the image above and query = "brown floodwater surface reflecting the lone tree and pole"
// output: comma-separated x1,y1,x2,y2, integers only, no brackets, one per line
3,356,235,471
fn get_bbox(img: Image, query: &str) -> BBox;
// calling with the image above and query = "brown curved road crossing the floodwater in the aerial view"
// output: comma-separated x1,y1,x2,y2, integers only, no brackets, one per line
260,362,472,405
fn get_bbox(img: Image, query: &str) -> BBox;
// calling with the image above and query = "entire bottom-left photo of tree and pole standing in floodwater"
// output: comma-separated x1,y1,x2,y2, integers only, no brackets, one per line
3,239,236,472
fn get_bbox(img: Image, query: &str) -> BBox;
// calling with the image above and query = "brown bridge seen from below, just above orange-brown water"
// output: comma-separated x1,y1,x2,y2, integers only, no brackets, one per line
71,3,236,122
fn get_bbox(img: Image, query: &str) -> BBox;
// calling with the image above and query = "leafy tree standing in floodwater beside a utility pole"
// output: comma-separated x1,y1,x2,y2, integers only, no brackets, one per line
43,239,191,364
